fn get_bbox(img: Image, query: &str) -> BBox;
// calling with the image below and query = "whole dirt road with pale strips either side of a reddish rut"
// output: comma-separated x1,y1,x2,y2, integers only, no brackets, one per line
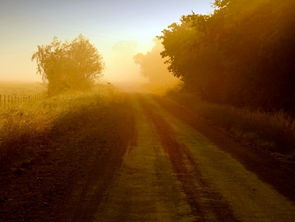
95,96,295,222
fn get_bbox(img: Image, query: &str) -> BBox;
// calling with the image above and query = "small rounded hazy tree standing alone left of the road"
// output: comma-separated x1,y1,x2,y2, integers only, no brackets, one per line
32,35,103,94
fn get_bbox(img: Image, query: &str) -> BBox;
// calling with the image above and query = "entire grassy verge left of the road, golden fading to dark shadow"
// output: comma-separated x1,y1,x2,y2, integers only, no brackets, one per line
0,86,134,222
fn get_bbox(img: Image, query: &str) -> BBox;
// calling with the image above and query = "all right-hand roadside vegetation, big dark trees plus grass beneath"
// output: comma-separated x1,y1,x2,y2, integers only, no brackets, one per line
158,0,295,159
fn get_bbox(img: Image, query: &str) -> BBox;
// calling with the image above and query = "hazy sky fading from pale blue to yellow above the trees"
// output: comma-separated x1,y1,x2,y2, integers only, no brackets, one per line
0,0,213,81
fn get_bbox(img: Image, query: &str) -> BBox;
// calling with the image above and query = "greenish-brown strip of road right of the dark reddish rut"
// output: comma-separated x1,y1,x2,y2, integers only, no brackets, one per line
146,96,295,222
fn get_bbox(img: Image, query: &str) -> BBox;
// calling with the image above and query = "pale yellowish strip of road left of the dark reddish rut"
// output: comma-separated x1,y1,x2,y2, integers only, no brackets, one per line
95,96,195,222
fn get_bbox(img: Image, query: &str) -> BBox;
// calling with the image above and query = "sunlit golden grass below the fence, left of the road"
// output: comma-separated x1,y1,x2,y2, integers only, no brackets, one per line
0,94,97,141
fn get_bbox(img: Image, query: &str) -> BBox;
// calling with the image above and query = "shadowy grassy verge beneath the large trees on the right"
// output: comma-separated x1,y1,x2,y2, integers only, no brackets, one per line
169,92,295,159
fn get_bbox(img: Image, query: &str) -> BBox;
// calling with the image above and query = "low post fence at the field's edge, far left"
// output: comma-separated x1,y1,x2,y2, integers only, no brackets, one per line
0,94,42,107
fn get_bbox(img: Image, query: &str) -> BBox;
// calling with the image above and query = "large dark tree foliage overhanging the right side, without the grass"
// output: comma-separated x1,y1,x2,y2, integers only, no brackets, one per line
159,0,295,111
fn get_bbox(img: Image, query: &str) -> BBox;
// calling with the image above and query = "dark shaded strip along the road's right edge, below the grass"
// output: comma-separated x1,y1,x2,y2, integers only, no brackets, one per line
153,96,295,202
